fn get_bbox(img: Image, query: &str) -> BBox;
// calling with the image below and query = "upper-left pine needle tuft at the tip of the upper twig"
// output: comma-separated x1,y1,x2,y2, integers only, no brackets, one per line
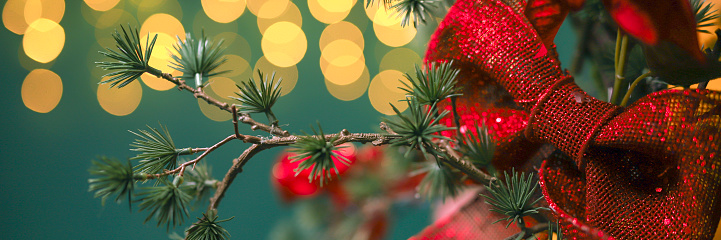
95,25,162,88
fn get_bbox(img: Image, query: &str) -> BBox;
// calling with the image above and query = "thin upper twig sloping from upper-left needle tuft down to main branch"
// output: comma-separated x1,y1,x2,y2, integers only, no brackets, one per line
161,73,290,137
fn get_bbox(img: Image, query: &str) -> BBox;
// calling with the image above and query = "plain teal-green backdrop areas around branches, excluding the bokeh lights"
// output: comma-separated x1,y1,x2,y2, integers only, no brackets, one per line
0,0,573,239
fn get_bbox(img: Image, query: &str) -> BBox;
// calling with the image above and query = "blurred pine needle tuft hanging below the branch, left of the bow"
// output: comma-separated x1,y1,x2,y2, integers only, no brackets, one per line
411,161,463,199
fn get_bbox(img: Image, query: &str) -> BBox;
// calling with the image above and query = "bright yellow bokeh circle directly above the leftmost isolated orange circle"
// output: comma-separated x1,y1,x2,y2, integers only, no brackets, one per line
23,18,65,63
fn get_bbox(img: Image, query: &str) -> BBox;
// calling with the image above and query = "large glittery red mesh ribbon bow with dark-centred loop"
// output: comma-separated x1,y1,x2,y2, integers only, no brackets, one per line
426,0,721,239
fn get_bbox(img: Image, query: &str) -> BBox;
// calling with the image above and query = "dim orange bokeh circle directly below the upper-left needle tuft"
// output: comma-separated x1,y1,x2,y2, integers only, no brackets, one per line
97,77,143,116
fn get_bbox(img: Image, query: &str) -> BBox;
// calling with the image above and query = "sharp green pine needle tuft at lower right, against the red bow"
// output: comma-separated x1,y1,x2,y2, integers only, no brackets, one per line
481,170,548,228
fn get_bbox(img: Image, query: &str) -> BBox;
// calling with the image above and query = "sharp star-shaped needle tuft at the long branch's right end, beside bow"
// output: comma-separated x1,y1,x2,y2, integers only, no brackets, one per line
384,98,454,158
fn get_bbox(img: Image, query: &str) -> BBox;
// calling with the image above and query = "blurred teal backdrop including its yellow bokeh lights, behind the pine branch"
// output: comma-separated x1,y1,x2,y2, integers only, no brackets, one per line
0,0,573,239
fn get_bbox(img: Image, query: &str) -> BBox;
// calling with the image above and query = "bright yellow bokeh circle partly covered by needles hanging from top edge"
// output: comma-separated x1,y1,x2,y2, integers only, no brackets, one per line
372,8,417,47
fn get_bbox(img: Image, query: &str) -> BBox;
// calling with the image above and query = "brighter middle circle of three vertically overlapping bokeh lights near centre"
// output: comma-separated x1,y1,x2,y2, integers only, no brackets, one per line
320,39,365,85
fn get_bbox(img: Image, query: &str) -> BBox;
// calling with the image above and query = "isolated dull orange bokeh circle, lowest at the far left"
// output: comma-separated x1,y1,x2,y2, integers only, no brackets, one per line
20,69,63,113
